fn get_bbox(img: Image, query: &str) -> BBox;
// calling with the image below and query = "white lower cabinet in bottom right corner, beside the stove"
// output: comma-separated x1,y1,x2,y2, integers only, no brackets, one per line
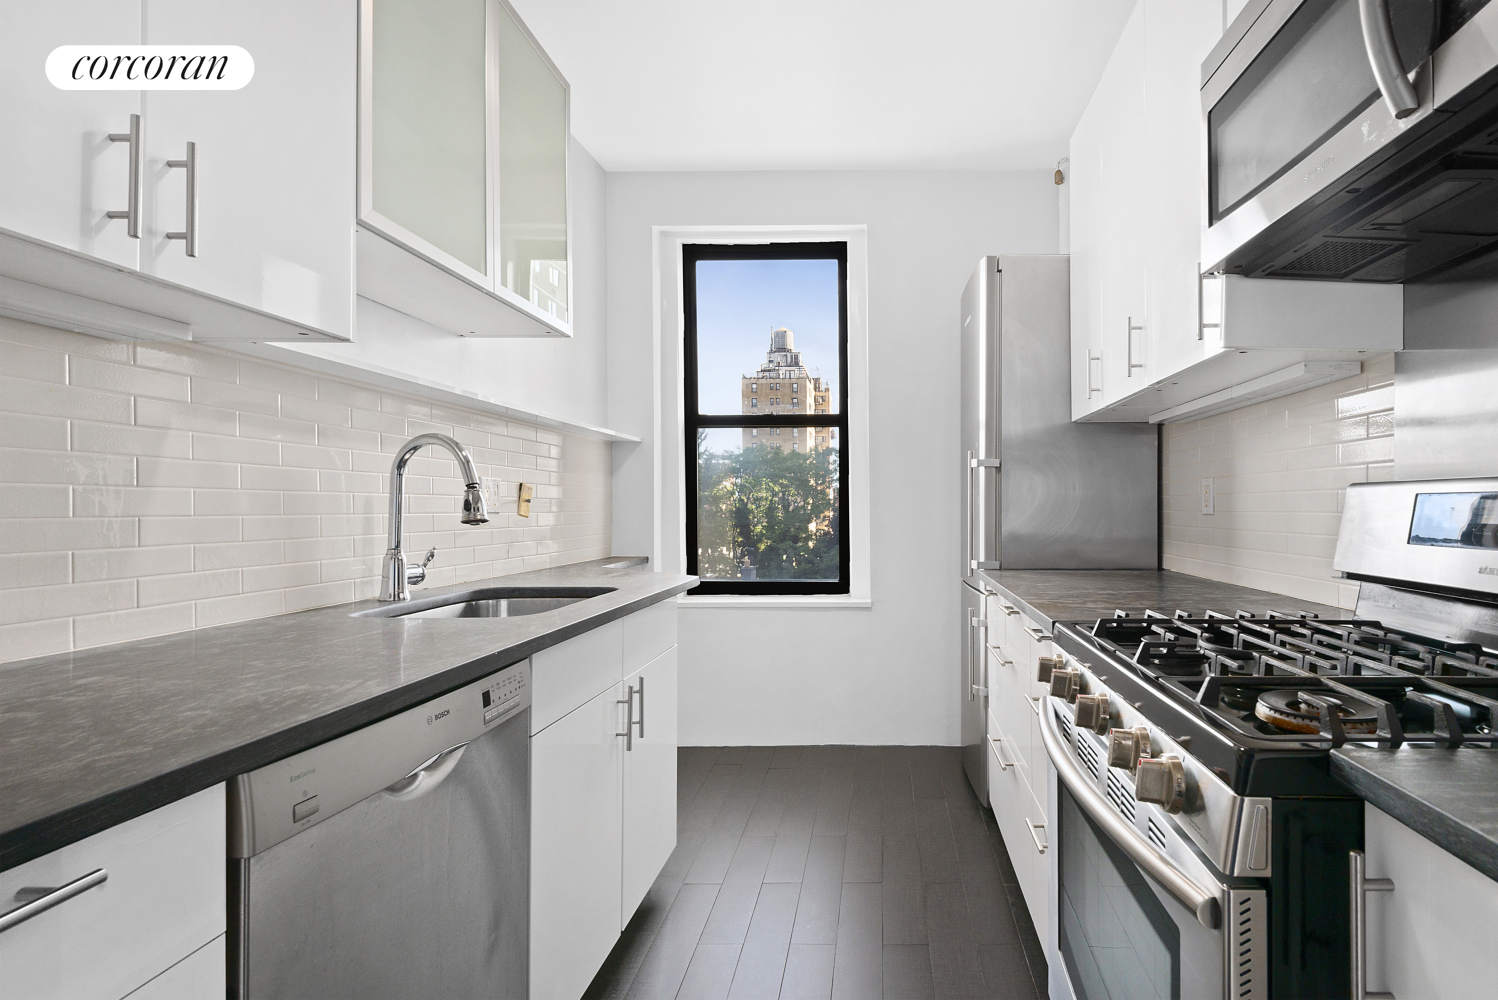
1363,802,1498,1000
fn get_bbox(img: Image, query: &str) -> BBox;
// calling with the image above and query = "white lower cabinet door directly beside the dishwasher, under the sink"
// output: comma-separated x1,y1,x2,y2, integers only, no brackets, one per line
530,684,625,1000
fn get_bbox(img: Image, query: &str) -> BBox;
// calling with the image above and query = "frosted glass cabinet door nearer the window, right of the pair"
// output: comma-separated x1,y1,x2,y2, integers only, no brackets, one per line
494,4,571,322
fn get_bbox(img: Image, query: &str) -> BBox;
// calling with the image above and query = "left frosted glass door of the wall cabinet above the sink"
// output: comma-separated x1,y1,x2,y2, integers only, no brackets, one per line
360,0,493,279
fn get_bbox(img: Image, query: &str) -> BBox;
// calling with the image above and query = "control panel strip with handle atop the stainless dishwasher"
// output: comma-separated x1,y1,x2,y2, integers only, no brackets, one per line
229,660,530,858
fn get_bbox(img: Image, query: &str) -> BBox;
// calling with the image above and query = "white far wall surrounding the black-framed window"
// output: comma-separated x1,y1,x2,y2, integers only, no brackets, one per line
608,169,1058,746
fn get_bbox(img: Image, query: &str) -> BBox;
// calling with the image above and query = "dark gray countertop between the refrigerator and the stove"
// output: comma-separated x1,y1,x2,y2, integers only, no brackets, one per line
981,569,1350,627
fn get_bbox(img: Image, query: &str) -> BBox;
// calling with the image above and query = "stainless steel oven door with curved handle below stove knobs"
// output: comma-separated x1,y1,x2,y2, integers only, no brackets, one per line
1040,698,1269,1000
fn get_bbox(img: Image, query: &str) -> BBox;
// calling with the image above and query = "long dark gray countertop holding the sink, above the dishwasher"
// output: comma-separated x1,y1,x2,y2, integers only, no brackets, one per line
0,557,695,871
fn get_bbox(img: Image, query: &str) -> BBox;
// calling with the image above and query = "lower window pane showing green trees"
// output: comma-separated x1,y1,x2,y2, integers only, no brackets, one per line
697,427,842,581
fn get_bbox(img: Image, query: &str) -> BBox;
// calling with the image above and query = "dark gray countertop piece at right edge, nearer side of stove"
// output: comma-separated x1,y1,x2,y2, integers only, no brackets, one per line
1332,746,1498,879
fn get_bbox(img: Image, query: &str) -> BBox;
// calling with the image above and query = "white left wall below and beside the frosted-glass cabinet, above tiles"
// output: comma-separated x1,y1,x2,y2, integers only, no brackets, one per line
286,139,608,427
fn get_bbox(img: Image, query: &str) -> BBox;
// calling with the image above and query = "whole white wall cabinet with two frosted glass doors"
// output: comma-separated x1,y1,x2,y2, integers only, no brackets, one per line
358,0,572,337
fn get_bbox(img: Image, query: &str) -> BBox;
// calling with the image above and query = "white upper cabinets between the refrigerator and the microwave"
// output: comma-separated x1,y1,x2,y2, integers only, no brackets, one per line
1070,0,1404,422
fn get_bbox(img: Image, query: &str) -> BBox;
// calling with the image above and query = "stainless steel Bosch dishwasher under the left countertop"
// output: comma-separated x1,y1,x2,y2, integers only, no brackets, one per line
229,660,530,1000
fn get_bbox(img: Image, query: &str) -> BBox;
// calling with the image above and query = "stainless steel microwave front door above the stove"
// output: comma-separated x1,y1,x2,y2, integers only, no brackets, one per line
1201,0,1438,277
